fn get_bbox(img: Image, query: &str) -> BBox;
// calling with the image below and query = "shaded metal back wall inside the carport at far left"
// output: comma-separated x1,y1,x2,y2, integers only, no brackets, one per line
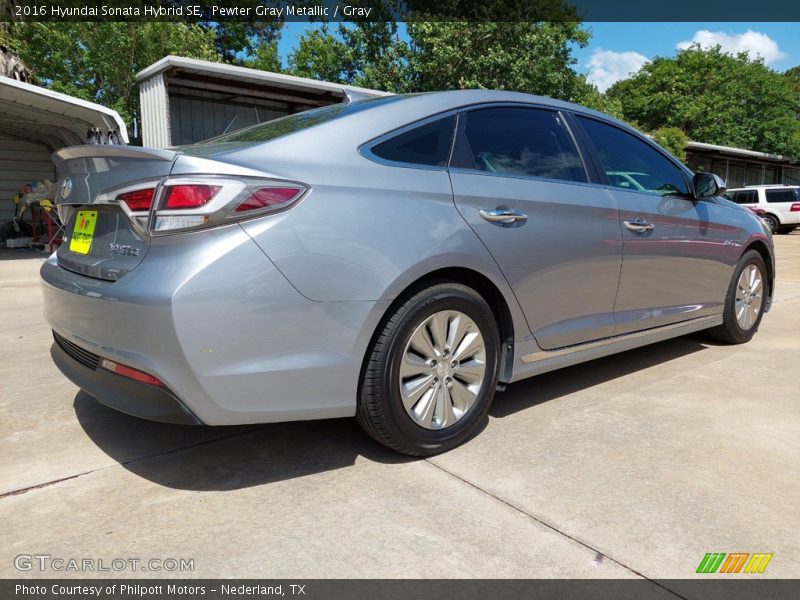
0,134,56,223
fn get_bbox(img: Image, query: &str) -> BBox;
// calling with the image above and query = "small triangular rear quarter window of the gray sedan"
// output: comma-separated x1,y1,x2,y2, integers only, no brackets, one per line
371,116,456,167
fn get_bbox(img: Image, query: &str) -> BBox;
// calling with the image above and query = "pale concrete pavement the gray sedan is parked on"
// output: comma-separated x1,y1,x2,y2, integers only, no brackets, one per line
0,232,800,579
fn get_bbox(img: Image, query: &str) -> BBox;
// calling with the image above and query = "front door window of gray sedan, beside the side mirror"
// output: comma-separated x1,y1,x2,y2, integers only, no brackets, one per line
578,116,689,196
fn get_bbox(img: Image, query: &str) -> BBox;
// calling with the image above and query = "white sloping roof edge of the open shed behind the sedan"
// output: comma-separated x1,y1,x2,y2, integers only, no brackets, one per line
136,55,391,98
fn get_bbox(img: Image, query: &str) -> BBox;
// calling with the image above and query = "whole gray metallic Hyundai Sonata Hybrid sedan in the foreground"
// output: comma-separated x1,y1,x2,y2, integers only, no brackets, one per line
41,90,775,455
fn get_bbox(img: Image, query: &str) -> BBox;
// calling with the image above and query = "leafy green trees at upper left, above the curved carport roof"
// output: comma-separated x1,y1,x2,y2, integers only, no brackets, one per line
10,22,218,139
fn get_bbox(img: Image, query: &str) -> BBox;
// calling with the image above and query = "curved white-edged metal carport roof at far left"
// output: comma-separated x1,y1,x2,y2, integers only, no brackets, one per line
0,76,128,150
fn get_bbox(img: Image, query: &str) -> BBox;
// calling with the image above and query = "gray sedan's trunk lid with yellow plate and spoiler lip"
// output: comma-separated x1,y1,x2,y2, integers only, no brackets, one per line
53,146,178,281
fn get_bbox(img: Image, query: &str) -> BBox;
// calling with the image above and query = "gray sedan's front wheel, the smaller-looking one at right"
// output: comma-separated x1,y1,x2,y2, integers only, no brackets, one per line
708,250,768,344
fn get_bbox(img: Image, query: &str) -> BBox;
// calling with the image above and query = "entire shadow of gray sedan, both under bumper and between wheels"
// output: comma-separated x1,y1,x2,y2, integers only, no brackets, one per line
73,336,706,490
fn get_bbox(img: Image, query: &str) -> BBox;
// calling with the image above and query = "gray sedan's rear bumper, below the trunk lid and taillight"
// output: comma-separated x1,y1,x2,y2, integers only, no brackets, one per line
41,225,386,425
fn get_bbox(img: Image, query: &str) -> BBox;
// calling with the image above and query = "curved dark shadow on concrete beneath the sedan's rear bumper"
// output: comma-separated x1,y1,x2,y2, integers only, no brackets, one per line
73,391,414,491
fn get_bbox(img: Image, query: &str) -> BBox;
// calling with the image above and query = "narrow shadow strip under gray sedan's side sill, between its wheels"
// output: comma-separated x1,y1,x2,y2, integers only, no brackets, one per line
489,332,713,418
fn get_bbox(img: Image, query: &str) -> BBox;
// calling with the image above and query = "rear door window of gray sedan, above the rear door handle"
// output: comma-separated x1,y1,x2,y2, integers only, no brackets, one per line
452,108,587,181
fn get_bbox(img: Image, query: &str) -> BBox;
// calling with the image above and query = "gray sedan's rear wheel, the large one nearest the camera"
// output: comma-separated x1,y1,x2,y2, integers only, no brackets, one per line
356,283,500,456
